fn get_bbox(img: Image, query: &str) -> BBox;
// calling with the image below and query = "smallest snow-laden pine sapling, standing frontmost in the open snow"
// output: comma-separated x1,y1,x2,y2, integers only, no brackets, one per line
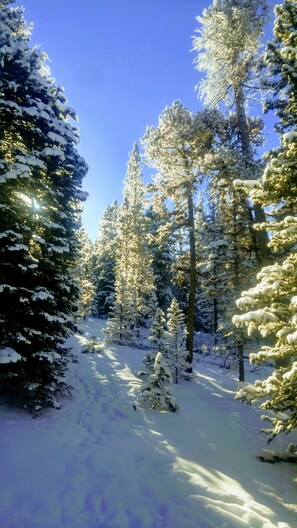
140,352,179,412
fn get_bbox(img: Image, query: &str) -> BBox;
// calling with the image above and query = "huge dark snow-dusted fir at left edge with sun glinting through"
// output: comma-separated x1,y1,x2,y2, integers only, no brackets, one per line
0,0,87,410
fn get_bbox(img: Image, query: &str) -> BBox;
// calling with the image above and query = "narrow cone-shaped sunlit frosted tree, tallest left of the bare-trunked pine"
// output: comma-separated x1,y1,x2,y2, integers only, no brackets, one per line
105,144,156,344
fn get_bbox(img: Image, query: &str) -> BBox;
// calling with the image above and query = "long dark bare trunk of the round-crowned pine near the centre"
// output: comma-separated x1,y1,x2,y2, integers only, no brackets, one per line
187,191,196,373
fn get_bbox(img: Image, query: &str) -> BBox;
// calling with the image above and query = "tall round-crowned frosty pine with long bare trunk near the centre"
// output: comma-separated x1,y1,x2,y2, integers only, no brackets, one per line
142,101,222,371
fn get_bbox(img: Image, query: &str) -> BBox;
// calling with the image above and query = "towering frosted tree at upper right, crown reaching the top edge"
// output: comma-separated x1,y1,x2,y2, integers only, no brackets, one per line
193,0,270,265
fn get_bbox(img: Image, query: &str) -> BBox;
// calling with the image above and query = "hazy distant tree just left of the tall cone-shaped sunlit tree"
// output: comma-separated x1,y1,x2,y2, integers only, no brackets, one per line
93,201,119,317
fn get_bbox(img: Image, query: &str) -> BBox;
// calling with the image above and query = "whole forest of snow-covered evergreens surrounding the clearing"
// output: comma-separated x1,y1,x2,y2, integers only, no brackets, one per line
0,0,297,456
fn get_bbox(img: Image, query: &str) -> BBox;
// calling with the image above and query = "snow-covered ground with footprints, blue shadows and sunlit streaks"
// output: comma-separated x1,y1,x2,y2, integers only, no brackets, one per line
0,319,297,528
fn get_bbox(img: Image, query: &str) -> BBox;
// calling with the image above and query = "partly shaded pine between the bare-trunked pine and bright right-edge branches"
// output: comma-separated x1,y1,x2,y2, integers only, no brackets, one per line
199,142,256,381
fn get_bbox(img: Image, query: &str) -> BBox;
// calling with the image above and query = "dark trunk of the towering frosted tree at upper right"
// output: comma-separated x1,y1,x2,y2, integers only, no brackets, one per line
235,87,271,267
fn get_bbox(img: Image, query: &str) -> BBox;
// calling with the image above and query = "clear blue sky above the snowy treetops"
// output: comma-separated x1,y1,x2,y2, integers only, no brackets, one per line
16,0,276,240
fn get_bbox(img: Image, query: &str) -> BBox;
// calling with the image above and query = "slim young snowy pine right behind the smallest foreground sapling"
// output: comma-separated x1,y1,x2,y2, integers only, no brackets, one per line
164,297,189,383
